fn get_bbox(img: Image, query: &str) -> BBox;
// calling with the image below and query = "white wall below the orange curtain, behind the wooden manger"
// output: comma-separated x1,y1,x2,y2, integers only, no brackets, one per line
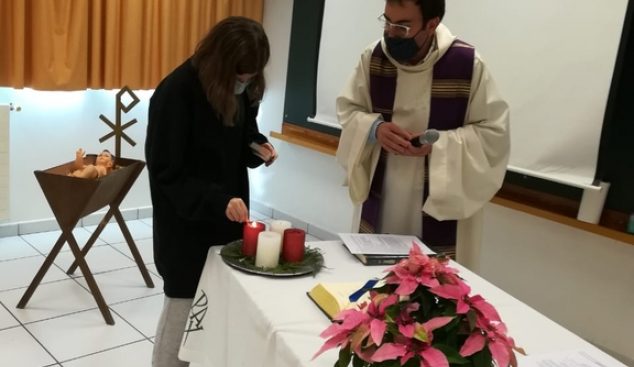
0,88,151,227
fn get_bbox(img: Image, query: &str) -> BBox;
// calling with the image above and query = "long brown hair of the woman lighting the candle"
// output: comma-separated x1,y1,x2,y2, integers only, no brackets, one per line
192,17,271,126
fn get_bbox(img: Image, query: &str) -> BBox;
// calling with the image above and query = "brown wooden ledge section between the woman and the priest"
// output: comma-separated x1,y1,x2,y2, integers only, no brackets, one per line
271,122,339,156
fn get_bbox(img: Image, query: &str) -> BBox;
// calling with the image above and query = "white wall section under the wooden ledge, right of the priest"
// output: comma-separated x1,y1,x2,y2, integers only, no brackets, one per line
481,204,634,366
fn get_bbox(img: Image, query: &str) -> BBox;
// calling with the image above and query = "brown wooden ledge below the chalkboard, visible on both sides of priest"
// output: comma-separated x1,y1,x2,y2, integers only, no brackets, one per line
271,122,634,245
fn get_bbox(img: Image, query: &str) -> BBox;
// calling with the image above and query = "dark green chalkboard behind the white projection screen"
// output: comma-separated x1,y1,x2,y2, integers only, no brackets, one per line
284,0,634,213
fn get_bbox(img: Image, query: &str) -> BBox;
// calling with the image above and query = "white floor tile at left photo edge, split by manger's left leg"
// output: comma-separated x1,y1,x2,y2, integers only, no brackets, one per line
0,256,69,292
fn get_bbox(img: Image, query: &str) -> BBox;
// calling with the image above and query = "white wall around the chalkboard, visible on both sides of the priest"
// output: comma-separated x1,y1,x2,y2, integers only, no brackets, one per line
252,0,634,366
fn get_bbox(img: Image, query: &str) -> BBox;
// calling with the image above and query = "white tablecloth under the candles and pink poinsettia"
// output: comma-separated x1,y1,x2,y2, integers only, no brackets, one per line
179,242,608,367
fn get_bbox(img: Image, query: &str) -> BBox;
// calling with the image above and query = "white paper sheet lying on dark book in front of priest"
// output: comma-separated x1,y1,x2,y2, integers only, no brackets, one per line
339,233,435,255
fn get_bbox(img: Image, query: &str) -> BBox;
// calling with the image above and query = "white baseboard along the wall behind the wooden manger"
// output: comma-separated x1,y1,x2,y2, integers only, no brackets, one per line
0,206,152,237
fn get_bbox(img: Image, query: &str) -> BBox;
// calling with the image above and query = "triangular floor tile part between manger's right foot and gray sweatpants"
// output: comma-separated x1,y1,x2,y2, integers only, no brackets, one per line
110,294,165,338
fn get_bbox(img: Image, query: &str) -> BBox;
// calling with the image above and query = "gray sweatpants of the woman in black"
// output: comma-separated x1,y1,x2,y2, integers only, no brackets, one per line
152,297,193,367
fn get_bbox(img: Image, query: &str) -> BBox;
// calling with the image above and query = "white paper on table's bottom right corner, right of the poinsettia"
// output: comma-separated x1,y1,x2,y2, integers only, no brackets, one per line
517,350,626,367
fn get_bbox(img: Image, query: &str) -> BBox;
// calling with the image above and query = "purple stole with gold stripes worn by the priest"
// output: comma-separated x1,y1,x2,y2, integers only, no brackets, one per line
359,40,475,252
